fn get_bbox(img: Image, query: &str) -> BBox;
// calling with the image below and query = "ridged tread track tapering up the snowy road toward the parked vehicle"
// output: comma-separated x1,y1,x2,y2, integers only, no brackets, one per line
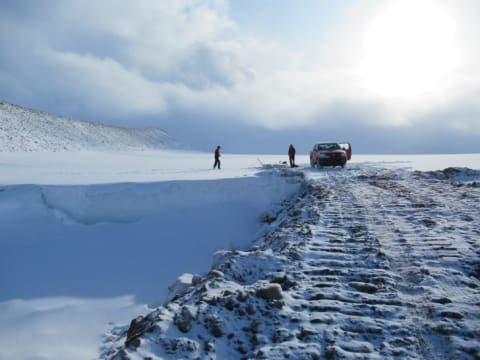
292,171,424,359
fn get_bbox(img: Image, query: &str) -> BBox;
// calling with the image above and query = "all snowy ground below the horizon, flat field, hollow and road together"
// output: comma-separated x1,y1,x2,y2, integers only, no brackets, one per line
0,151,480,359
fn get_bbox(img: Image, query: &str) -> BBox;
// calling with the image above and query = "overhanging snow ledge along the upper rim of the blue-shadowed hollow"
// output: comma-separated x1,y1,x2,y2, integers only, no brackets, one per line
40,175,298,224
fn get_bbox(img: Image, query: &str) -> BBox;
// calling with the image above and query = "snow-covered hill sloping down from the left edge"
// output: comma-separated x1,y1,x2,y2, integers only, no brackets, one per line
0,100,175,152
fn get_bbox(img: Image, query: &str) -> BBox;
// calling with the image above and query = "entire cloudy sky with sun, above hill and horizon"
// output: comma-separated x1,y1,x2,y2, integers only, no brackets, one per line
0,0,480,154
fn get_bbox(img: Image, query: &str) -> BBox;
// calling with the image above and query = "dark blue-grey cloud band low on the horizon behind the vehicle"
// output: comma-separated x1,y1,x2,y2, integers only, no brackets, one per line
155,98,480,154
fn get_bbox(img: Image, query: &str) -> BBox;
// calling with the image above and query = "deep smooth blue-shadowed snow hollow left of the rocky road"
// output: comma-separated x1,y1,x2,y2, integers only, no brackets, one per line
0,171,301,359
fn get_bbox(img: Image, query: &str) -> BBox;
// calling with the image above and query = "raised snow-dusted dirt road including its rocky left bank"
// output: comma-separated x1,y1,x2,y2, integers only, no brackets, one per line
104,165,480,359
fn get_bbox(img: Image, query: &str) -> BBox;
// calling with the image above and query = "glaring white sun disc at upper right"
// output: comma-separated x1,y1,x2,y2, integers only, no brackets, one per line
359,0,457,98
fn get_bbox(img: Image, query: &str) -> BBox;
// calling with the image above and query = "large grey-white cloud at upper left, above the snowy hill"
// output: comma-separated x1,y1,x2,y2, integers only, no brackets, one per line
0,0,240,121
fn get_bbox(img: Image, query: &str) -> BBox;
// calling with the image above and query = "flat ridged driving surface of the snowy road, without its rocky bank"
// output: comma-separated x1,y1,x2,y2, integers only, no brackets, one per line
296,165,480,359
